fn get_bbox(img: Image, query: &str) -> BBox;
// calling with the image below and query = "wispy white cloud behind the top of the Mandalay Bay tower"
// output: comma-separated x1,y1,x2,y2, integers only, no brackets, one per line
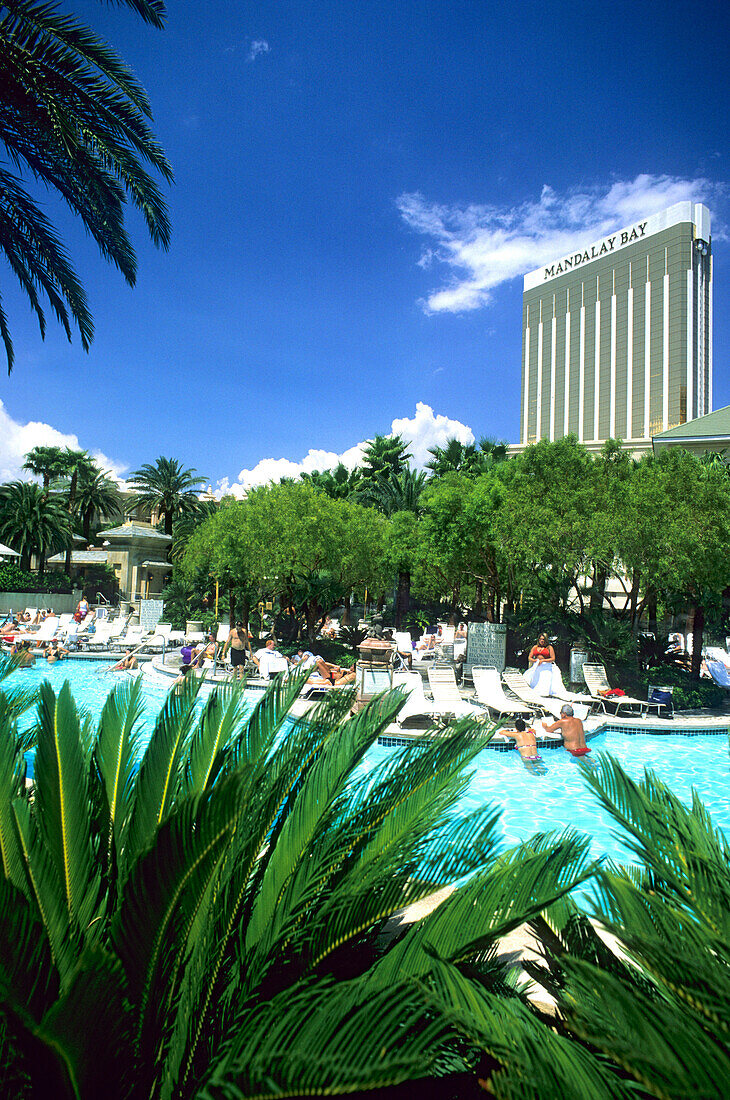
397,174,727,314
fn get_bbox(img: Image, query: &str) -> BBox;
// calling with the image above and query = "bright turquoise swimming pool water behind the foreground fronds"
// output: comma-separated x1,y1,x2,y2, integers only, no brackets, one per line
13,661,730,860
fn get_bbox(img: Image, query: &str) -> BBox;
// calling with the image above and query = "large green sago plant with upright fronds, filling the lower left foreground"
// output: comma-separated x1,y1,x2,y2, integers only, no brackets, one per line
0,678,609,1100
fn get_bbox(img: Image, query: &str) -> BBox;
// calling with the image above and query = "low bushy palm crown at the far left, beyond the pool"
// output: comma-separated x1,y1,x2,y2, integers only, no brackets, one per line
0,482,70,574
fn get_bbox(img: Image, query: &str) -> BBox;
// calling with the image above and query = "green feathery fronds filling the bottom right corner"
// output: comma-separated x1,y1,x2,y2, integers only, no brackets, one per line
530,756,730,1098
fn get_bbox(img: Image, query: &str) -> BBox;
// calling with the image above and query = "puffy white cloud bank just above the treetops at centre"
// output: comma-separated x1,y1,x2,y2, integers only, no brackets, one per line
215,402,474,497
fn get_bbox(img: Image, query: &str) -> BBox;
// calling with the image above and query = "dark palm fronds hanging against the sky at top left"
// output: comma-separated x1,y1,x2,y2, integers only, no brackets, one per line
0,0,172,372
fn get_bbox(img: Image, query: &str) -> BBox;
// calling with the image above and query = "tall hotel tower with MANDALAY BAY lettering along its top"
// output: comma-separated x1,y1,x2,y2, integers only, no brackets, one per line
520,202,712,449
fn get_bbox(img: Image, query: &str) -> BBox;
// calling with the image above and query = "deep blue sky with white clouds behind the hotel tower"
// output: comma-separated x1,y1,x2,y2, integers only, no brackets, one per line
0,0,730,487
